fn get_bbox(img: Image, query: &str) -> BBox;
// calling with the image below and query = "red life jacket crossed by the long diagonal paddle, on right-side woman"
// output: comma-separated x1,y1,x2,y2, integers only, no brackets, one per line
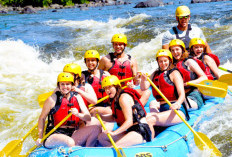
152,68,178,101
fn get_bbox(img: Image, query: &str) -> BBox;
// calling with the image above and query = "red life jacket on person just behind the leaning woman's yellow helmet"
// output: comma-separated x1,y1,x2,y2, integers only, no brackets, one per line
82,69,107,99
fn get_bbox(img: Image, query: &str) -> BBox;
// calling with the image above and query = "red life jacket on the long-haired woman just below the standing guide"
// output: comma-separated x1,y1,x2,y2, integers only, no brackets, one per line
176,58,197,83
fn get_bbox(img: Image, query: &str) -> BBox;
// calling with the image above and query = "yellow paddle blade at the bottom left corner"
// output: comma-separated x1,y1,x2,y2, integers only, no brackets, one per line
0,140,23,157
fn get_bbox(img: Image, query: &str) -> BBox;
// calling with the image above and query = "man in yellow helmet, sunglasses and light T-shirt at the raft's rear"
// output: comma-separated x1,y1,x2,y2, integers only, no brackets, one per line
162,5,211,53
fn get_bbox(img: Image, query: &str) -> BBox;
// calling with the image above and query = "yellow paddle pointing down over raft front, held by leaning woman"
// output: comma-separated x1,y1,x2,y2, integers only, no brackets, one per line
96,113,126,157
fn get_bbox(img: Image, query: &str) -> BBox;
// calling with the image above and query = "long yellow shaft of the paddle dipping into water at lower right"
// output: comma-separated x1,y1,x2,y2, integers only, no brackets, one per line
147,77,216,156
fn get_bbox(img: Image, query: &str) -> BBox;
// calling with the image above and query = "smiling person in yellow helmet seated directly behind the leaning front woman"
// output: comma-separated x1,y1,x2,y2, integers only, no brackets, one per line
81,50,112,114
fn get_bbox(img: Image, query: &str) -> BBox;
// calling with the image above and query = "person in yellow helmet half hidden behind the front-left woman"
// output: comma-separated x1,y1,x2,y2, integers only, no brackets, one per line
63,63,97,107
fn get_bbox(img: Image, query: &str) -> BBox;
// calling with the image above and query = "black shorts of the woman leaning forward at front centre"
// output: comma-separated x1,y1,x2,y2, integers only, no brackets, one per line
127,123,151,142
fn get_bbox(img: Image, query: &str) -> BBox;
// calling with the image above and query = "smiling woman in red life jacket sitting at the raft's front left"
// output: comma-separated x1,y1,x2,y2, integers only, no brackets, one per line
36,72,100,148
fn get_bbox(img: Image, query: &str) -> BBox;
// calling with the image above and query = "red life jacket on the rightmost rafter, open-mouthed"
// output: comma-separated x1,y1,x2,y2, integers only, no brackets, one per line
199,53,220,80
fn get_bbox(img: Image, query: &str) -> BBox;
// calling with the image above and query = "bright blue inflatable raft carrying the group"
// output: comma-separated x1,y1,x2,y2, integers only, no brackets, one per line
30,87,224,157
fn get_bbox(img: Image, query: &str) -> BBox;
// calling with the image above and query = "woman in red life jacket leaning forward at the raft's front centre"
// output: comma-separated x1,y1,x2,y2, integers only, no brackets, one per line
98,75,154,147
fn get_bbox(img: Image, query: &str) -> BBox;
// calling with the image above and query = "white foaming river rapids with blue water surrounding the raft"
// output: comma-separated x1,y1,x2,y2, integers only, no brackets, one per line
0,0,232,156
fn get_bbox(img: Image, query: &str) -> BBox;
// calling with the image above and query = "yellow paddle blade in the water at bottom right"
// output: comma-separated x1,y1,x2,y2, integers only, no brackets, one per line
194,132,222,157
